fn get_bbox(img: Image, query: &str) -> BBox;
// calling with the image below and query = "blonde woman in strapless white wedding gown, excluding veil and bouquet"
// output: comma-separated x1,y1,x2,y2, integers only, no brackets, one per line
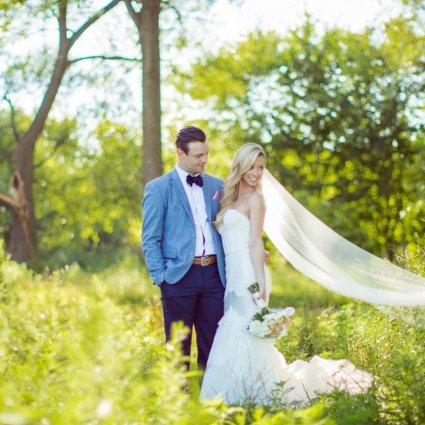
200,143,373,405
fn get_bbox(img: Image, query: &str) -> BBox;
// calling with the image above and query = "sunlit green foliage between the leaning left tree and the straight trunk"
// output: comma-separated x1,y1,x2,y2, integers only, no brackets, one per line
36,119,142,266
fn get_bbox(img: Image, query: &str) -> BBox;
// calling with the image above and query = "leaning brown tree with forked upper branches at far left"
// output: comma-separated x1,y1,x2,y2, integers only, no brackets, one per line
0,0,120,262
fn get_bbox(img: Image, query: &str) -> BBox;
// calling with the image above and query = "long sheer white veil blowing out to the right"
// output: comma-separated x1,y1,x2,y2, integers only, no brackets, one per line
262,170,425,310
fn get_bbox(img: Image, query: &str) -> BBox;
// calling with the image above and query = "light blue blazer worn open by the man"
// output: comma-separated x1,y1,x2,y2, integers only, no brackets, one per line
142,169,226,286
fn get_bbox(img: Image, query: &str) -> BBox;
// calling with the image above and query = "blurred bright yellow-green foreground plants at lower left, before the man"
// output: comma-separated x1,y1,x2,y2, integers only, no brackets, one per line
0,245,195,424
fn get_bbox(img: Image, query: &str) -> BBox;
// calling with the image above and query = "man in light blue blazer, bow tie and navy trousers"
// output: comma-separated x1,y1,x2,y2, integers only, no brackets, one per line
142,126,225,368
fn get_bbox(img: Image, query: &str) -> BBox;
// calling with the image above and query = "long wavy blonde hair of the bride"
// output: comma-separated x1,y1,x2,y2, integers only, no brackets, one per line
214,143,266,228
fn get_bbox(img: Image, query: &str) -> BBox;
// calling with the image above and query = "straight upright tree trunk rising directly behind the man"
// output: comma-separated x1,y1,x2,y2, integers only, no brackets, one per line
139,0,162,184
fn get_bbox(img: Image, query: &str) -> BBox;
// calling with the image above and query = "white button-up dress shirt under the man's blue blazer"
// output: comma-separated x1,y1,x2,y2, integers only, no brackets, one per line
176,165,215,257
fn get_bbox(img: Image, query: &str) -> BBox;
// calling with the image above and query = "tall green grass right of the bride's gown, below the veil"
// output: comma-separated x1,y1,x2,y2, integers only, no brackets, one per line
271,252,425,425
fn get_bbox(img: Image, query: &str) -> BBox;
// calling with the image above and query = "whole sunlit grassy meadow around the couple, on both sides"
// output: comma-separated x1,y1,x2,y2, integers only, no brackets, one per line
0,245,425,425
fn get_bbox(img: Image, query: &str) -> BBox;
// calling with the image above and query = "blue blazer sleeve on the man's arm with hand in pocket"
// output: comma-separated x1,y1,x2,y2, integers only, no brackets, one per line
142,183,166,285
